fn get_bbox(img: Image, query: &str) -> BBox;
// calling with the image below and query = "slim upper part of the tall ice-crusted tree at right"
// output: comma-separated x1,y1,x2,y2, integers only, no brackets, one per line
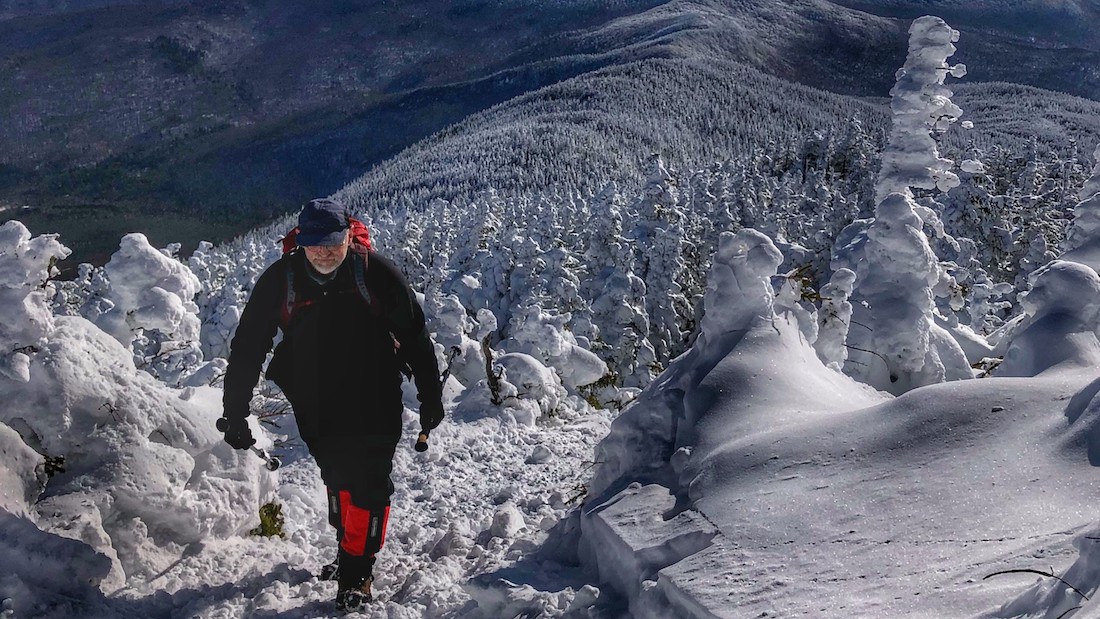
876,15,966,203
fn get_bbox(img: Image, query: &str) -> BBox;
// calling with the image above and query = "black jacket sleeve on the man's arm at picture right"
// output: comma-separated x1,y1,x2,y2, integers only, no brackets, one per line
370,254,443,404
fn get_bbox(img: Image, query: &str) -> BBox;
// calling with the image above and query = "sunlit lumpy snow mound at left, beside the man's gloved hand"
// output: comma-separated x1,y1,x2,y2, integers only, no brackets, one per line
0,317,274,594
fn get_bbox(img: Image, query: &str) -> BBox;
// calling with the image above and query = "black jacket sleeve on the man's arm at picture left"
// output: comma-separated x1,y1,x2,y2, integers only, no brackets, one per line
222,261,286,419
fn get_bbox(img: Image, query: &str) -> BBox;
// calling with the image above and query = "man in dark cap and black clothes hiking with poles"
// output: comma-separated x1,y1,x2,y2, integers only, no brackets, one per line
221,199,443,610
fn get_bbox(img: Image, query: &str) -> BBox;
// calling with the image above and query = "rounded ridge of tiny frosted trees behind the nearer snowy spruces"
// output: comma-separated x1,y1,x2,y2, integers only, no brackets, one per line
341,58,887,208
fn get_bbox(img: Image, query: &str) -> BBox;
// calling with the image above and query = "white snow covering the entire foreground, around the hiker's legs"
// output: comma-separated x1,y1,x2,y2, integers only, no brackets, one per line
0,223,1100,618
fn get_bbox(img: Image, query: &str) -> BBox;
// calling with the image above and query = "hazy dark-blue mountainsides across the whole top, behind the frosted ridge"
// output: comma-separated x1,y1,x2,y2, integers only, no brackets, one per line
0,0,1100,264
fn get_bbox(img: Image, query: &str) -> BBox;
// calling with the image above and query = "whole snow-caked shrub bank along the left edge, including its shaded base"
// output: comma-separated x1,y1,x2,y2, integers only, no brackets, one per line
0,222,274,616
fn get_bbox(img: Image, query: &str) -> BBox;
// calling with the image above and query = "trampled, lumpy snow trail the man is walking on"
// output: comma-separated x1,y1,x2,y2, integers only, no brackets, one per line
108,391,611,619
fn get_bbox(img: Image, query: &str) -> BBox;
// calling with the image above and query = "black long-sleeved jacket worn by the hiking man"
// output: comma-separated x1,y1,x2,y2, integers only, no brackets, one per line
223,251,441,443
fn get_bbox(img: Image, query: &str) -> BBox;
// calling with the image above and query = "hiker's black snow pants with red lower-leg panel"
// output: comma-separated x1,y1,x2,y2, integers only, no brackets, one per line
309,436,397,588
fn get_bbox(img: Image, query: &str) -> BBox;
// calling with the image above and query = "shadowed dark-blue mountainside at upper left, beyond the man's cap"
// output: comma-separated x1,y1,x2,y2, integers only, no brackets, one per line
0,0,656,259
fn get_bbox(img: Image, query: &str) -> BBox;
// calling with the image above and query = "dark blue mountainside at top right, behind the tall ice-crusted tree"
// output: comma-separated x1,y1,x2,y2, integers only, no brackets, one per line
651,0,1100,99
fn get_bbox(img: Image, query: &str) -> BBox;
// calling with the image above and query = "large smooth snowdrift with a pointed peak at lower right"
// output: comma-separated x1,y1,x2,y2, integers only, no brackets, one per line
582,274,1100,617
